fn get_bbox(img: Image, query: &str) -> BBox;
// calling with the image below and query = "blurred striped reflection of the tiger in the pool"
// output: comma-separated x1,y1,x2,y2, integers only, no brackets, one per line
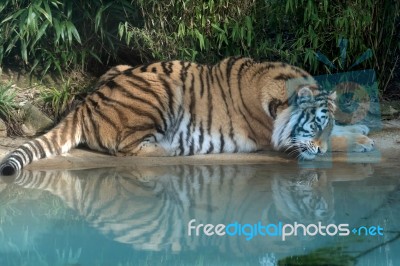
1,165,370,255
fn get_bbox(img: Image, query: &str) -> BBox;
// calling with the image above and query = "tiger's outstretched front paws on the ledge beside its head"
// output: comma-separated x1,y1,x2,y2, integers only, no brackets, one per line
331,125,375,152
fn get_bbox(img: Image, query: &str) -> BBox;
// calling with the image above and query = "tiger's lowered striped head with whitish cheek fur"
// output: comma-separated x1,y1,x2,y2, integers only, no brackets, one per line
272,86,336,160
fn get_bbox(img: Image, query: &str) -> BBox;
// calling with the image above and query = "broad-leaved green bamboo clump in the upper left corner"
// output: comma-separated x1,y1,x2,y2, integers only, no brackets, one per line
0,0,139,74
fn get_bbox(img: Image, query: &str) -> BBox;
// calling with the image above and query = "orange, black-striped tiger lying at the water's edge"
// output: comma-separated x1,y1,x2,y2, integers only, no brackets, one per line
0,57,374,175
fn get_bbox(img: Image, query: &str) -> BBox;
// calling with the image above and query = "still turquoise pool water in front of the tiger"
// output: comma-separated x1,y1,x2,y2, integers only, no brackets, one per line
0,163,400,266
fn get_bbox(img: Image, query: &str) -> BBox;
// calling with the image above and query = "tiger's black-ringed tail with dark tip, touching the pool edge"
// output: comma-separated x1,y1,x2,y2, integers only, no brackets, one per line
0,108,83,176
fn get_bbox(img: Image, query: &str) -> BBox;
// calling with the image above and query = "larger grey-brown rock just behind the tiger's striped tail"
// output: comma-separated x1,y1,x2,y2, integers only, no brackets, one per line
21,103,53,136
